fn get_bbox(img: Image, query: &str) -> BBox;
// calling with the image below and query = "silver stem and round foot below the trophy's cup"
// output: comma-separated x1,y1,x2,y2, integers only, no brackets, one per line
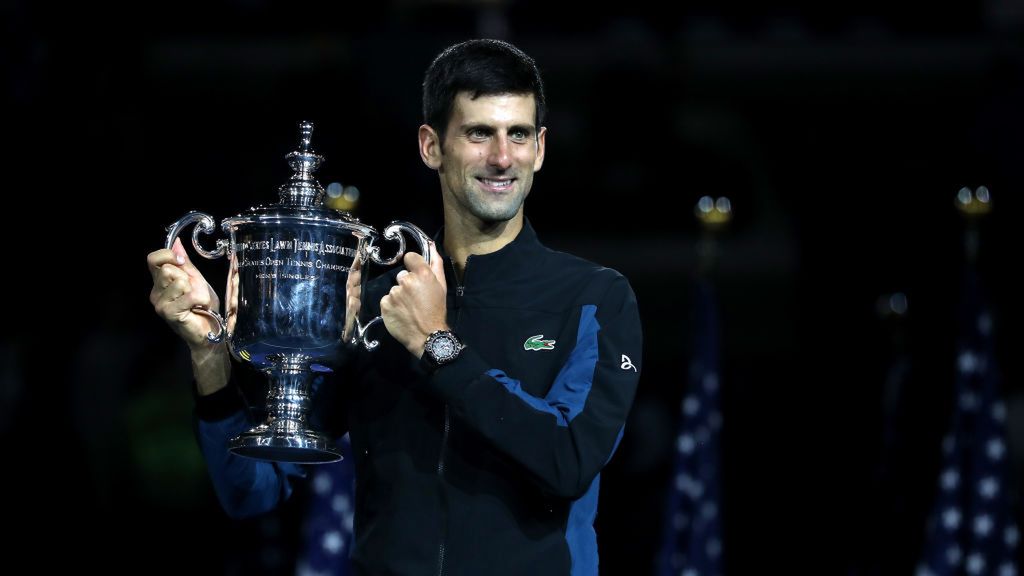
228,354,341,464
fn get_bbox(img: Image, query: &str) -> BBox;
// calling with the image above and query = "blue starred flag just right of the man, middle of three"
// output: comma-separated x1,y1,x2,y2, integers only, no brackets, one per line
657,280,722,576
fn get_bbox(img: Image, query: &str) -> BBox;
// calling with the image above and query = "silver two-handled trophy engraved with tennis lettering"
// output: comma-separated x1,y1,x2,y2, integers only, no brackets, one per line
166,122,430,463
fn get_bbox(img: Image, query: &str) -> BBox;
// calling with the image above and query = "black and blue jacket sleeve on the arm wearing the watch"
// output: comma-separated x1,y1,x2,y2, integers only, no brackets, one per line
429,276,642,499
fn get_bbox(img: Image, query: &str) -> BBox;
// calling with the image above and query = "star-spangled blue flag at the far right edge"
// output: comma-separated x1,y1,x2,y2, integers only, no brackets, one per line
916,269,1020,576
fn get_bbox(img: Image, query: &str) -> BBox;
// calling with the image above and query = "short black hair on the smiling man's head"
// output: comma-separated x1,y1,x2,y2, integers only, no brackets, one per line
423,39,546,139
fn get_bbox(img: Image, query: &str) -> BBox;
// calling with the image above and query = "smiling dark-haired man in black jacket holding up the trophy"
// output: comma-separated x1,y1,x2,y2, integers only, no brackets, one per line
148,40,641,576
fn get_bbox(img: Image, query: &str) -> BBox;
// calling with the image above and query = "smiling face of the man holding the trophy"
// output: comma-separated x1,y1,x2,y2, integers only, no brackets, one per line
437,92,545,224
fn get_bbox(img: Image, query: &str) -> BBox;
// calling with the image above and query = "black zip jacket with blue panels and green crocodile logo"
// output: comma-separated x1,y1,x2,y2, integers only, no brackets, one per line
197,221,642,576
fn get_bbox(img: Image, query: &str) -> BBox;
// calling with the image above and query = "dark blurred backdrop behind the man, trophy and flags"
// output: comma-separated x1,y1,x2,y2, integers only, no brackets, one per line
0,0,1024,574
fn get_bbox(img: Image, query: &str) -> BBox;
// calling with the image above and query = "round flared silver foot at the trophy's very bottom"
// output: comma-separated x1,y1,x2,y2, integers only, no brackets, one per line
227,424,341,464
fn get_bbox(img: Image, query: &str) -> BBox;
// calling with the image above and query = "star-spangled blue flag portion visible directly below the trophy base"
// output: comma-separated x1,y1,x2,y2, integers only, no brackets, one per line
295,435,355,576
